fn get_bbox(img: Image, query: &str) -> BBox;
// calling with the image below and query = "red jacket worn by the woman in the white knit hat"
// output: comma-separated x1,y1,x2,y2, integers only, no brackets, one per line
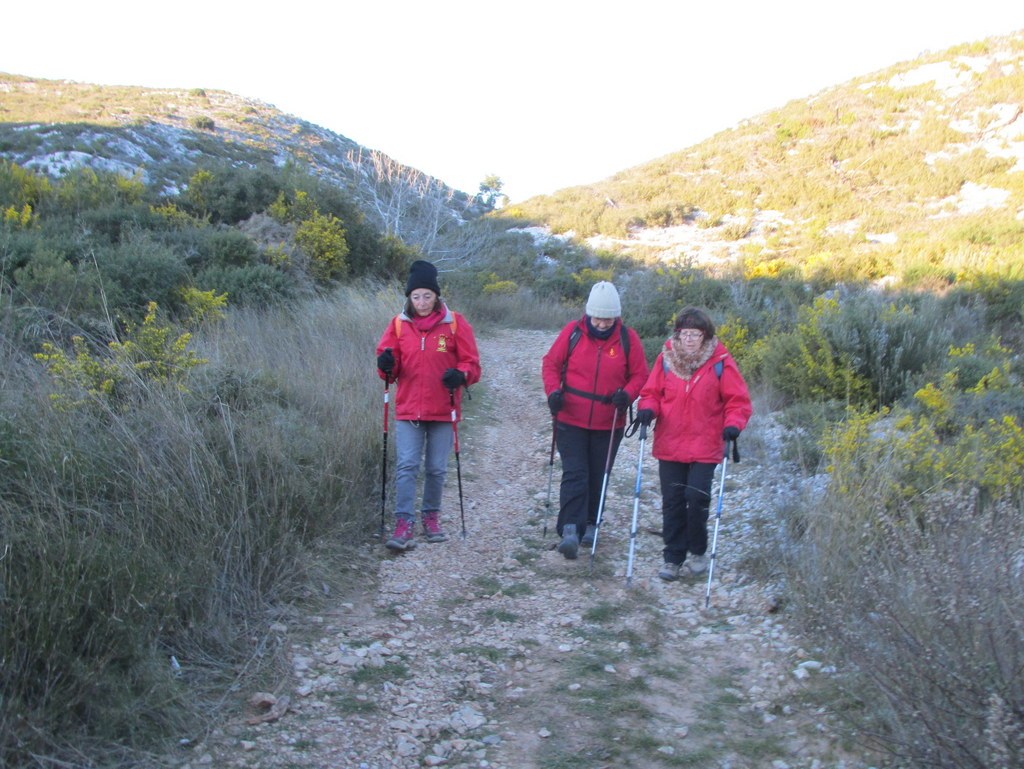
541,315,647,430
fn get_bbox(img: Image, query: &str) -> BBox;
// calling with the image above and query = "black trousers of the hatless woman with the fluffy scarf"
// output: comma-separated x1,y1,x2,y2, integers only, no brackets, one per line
657,460,718,563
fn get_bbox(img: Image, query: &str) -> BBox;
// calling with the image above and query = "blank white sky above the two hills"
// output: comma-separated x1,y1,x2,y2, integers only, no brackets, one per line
0,0,1024,201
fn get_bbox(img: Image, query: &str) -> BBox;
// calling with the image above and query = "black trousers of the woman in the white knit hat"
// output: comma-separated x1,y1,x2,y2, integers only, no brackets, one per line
555,422,624,537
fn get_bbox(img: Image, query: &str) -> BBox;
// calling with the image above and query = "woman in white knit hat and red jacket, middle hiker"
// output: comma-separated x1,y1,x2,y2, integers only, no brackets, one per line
541,282,647,559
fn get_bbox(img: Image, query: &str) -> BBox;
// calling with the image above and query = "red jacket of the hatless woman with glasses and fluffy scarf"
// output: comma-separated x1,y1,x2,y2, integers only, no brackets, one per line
639,340,754,464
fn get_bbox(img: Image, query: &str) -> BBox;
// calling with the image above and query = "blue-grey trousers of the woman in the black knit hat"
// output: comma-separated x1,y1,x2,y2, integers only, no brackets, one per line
394,419,455,520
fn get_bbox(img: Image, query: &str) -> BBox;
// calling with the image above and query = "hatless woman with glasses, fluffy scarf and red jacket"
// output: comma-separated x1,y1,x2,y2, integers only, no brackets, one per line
637,307,754,582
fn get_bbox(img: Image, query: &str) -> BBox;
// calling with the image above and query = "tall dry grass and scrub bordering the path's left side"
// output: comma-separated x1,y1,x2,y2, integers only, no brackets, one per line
0,284,392,766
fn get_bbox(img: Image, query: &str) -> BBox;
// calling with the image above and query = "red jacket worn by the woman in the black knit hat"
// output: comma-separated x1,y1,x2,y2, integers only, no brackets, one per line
377,307,480,422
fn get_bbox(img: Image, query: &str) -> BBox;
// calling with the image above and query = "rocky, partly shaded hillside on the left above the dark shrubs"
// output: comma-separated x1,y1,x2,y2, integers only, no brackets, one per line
0,73,481,217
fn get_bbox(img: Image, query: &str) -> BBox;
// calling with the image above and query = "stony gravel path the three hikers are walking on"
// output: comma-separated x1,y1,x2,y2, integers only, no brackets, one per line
189,331,867,769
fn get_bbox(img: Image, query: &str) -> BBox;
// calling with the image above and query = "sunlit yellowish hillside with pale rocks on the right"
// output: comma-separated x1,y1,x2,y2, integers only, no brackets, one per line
506,33,1024,276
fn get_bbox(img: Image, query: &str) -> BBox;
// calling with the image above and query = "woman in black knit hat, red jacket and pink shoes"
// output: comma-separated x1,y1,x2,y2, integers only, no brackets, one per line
377,261,480,552
